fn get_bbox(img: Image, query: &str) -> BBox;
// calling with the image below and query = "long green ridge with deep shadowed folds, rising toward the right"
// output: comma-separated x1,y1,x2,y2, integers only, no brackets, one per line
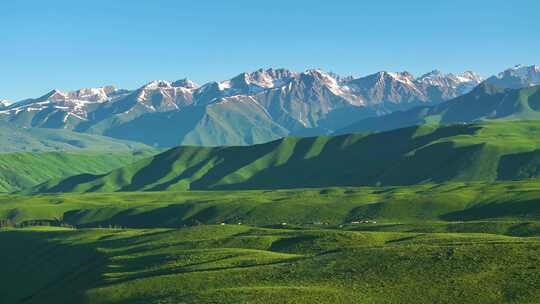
30,121,540,192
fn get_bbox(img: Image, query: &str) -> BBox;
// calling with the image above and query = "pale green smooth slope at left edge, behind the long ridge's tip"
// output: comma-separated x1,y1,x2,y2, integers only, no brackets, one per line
0,149,156,192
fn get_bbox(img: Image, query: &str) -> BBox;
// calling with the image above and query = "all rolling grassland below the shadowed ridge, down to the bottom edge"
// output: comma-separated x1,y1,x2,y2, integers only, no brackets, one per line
0,180,540,304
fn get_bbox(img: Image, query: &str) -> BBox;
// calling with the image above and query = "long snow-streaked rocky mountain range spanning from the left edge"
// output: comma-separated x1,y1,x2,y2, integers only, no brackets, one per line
0,69,482,146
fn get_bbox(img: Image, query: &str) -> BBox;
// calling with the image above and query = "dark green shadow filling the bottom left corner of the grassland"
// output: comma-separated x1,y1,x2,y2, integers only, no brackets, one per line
0,230,106,304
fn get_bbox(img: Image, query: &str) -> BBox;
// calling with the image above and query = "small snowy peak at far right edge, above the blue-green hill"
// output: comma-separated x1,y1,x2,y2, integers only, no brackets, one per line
486,65,540,89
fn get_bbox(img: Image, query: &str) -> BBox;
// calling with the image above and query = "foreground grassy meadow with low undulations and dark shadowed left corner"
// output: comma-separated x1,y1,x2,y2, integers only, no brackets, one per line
0,225,540,304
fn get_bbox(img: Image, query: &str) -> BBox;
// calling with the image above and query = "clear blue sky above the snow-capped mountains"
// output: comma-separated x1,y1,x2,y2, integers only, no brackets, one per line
0,0,540,101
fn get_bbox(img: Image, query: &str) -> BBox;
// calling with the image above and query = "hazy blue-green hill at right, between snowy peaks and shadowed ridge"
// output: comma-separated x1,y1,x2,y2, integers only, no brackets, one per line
335,83,540,134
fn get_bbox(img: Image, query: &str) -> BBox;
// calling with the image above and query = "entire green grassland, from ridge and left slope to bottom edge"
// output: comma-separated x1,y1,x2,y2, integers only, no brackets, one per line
0,121,540,304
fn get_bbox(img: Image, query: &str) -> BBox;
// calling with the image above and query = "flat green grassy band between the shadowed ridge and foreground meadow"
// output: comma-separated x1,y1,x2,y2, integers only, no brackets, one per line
0,180,540,228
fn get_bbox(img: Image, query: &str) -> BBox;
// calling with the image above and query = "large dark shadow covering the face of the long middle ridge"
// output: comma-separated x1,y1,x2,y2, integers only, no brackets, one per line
201,125,481,190
